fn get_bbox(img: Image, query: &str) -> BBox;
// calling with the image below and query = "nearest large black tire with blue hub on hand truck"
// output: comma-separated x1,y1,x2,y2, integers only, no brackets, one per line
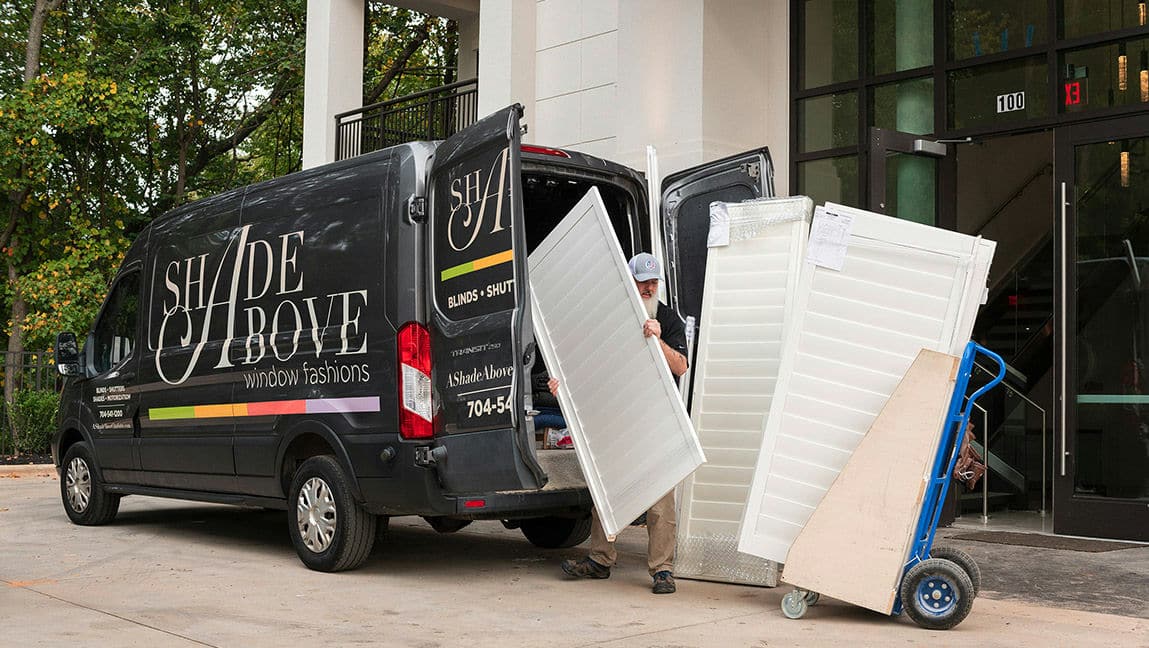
901,558,973,630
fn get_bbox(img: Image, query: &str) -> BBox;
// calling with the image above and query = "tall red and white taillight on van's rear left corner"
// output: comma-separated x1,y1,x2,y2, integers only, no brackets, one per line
396,322,434,439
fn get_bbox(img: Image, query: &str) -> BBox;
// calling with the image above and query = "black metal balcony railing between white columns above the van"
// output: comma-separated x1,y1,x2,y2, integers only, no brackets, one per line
336,79,479,160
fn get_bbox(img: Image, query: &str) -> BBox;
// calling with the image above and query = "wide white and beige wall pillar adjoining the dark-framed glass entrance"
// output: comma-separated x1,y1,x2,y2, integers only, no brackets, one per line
615,0,789,183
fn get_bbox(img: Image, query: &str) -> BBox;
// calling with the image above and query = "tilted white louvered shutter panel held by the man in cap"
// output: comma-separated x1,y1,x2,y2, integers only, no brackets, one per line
529,188,705,535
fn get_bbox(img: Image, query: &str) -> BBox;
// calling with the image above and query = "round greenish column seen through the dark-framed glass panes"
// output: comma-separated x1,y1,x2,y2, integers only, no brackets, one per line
894,0,938,225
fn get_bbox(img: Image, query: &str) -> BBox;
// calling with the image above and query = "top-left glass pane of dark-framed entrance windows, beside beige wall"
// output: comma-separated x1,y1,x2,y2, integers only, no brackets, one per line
801,0,858,88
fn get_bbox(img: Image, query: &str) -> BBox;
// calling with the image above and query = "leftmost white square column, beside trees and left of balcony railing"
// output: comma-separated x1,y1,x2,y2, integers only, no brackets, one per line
303,0,364,169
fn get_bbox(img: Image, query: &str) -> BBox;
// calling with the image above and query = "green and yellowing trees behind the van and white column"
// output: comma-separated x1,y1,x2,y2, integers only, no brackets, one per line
0,0,453,450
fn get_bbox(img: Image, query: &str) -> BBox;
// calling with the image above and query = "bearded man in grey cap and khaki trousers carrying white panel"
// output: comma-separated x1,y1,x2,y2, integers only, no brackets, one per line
549,252,686,594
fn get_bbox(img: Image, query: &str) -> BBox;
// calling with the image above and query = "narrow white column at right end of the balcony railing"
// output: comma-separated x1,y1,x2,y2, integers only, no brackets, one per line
480,0,538,133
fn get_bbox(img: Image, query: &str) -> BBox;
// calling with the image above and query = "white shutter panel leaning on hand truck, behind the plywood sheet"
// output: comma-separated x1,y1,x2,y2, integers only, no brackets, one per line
739,203,994,562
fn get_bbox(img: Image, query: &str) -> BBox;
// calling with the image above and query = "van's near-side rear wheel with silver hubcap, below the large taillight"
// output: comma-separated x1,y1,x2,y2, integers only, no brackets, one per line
287,455,376,571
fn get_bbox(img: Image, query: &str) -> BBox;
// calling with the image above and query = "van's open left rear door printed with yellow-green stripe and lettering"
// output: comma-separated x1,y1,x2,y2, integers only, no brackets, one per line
427,105,546,493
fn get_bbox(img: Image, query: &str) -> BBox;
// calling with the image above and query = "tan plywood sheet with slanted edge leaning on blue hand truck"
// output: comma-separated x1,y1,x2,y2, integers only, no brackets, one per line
784,349,961,614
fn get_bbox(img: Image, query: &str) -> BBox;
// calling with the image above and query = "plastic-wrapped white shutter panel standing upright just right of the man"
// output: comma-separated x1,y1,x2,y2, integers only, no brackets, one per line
674,196,813,586
